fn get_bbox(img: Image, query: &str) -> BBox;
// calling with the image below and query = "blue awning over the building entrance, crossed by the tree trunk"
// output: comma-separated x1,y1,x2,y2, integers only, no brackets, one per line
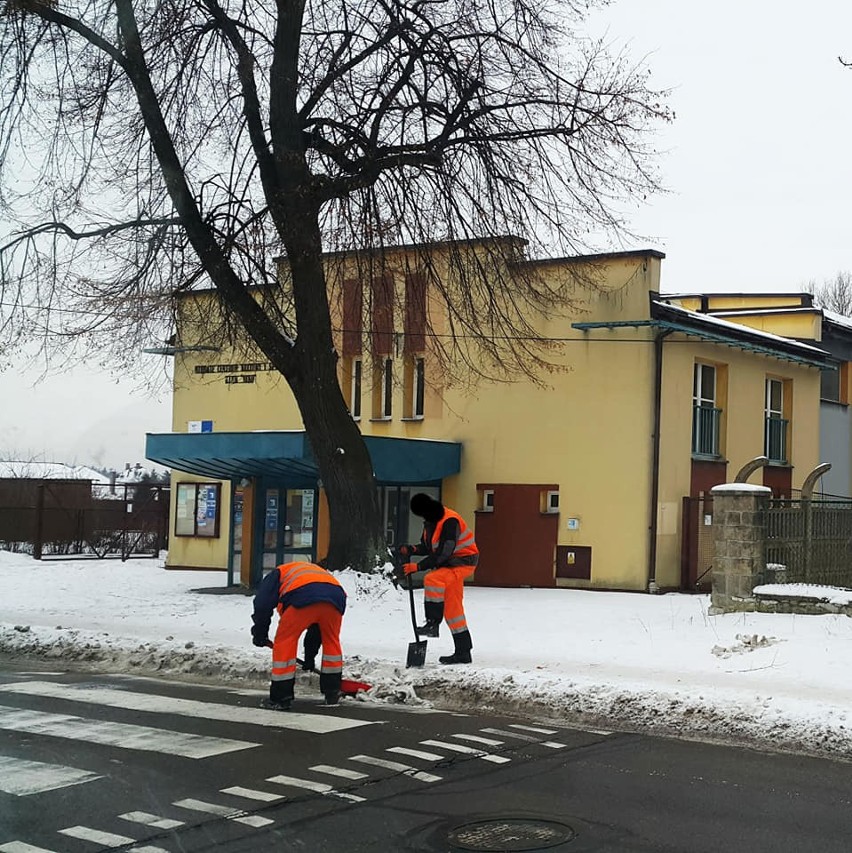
145,430,461,488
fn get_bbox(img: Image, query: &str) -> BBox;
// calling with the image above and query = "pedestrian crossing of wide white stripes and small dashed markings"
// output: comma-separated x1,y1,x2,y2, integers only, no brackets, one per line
0,674,604,853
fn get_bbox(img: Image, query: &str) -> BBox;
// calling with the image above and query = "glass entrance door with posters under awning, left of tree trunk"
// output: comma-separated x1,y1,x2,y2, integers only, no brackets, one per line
260,486,317,573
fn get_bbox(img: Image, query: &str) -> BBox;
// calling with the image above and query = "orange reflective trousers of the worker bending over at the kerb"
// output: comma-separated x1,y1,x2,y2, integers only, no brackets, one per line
272,601,343,696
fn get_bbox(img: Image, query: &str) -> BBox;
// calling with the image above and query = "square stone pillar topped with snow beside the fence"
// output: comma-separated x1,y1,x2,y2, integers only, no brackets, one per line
710,483,772,613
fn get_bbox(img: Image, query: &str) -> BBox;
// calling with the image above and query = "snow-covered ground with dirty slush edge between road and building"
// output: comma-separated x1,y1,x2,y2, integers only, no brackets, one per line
0,552,852,759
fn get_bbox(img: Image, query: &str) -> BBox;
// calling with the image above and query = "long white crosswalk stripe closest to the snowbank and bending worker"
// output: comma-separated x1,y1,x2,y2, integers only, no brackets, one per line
0,681,378,734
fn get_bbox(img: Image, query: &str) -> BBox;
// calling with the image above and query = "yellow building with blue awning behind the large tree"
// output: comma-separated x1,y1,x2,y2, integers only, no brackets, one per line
147,240,827,590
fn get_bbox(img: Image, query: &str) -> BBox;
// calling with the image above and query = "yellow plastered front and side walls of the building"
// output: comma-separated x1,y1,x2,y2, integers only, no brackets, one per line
160,246,819,590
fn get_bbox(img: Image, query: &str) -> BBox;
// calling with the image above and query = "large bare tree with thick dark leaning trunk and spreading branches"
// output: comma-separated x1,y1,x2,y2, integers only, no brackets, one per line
0,0,669,568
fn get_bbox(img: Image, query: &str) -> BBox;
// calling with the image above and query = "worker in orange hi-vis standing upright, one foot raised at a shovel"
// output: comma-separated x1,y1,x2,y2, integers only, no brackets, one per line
399,493,479,664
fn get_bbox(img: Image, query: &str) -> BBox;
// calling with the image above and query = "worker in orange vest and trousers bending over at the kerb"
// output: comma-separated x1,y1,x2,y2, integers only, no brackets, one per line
251,563,346,711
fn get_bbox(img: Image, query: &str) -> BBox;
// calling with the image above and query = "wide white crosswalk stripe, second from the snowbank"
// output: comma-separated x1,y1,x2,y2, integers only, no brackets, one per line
0,705,259,758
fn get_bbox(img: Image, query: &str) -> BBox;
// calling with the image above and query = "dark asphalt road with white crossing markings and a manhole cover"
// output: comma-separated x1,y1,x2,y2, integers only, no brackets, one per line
0,667,852,853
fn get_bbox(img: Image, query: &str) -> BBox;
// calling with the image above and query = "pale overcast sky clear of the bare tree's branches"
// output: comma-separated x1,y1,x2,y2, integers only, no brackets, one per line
0,0,852,467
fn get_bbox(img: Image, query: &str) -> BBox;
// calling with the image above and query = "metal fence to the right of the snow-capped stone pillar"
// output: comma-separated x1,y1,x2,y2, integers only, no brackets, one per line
764,498,852,586
